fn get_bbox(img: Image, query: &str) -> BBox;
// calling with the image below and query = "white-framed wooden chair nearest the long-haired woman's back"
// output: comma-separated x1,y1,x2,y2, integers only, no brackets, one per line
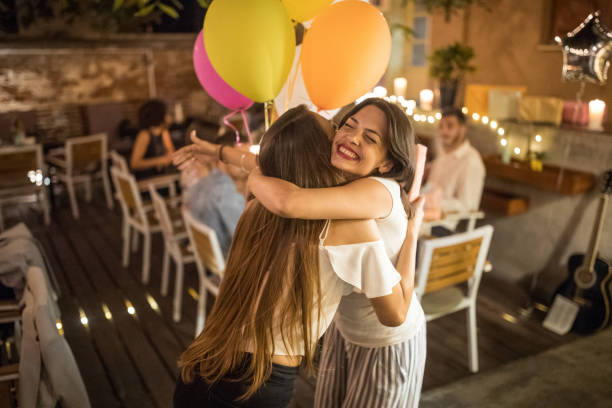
182,210,225,337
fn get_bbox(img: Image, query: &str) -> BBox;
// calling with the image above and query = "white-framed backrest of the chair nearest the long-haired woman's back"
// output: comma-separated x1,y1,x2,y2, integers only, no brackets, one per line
183,209,225,277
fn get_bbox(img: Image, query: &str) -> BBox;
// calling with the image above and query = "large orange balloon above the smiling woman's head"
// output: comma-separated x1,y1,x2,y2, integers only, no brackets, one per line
301,0,391,109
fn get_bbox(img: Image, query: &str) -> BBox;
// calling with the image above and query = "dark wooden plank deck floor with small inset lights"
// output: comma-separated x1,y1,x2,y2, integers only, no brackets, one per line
5,189,575,408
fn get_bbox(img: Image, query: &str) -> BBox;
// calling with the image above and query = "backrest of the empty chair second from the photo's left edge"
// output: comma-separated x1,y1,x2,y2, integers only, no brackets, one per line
66,133,108,171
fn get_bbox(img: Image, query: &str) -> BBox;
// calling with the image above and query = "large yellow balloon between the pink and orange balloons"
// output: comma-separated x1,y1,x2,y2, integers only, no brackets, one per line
204,0,295,102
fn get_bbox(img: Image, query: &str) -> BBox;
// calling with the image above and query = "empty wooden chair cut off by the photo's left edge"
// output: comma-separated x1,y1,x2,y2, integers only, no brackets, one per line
0,144,51,231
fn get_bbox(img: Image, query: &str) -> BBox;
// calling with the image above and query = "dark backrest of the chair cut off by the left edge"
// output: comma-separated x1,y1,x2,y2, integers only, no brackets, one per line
0,144,43,188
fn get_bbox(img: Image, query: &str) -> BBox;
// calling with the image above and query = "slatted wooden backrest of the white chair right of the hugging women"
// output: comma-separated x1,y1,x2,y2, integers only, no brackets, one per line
416,225,493,298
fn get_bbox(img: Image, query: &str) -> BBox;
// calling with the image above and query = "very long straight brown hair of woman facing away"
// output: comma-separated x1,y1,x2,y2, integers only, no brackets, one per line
179,106,339,398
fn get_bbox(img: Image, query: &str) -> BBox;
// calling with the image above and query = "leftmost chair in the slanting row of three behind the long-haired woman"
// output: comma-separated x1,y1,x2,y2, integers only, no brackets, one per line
111,166,162,284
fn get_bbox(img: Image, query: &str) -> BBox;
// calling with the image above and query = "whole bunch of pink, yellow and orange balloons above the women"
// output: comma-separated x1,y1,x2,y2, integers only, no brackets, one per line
193,0,391,138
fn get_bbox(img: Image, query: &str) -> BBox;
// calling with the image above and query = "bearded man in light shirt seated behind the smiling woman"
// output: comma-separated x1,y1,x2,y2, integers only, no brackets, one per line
423,108,485,236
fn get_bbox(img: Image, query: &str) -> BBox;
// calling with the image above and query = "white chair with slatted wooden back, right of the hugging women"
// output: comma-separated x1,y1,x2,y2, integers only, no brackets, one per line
415,225,493,373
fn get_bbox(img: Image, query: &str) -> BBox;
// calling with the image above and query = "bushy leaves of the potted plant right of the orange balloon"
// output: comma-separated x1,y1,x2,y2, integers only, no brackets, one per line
428,42,476,81
